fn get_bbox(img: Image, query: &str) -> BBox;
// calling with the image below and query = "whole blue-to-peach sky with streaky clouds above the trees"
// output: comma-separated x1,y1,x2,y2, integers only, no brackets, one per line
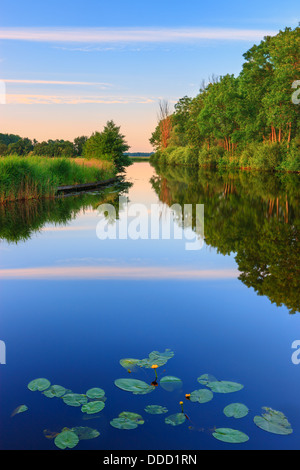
0,0,300,152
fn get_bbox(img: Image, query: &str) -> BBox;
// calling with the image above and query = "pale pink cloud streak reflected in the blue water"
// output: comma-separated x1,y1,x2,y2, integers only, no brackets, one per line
0,266,239,281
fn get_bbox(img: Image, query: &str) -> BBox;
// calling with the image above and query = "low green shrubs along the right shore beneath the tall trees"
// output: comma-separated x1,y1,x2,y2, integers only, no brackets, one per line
151,142,300,172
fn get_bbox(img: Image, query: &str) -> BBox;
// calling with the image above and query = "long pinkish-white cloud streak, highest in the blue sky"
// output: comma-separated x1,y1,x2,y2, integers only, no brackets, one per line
0,27,277,44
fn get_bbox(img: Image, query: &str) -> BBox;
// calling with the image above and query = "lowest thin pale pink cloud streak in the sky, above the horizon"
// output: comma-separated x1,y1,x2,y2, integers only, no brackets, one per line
6,93,157,104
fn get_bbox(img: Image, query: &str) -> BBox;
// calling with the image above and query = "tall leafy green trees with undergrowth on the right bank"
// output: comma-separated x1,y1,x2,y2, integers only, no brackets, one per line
150,26,300,171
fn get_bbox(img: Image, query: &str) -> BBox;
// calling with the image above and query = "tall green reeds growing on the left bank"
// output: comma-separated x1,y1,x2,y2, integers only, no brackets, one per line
0,156,116,204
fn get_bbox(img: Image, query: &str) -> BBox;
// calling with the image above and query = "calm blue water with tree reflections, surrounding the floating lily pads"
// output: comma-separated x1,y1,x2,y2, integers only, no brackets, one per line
0,162,300,450
